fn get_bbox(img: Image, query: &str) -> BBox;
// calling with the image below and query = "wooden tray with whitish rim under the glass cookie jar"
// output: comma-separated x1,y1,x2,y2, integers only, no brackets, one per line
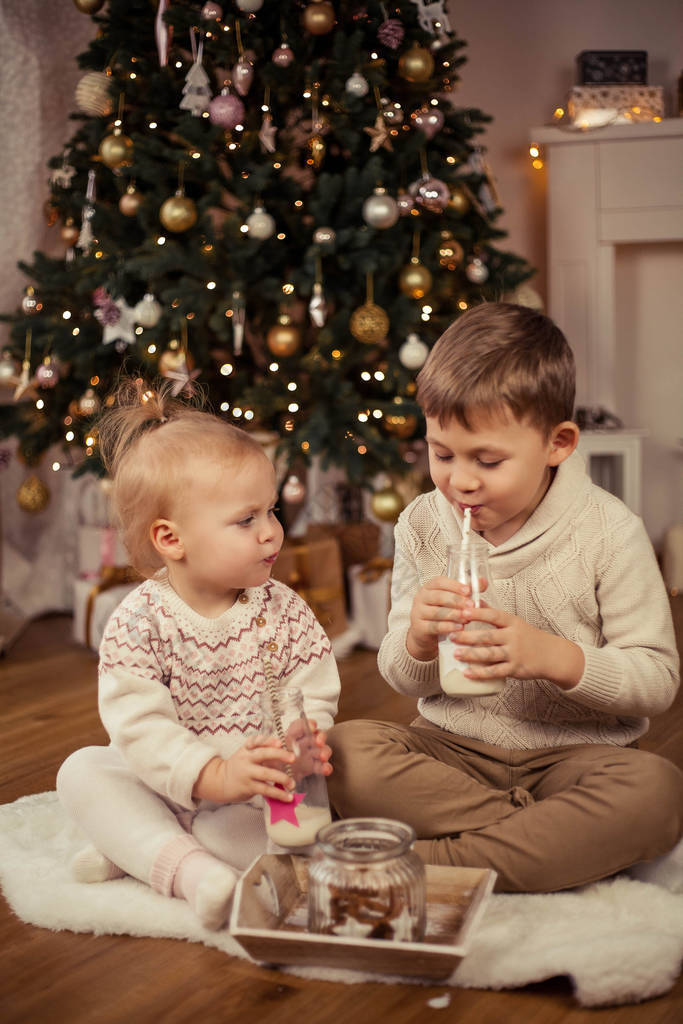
230,854,496,978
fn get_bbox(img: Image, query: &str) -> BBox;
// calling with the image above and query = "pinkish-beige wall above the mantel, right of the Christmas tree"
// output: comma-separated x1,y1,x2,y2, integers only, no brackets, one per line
447,0,683,296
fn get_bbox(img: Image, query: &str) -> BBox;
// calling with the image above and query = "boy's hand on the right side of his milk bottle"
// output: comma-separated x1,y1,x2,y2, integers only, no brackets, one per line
454,607,585,690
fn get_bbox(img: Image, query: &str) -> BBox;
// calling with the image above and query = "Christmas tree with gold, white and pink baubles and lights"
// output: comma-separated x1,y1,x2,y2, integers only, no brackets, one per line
0,0,530,520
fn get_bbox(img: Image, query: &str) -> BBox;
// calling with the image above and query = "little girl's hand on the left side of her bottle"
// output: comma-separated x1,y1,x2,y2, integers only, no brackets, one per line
193,735,295,804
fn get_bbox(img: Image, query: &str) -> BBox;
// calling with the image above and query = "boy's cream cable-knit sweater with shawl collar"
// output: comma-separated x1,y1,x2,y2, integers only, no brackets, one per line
379,453,678,750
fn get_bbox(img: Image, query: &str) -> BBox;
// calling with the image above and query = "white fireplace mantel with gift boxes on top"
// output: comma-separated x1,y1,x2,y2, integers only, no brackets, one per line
530,118,683,415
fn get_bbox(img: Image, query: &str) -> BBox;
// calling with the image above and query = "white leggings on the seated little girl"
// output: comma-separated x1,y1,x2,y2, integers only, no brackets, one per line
57,746,267,885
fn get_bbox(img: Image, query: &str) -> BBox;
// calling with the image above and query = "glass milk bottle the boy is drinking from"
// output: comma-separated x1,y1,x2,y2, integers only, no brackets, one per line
438,520,505,697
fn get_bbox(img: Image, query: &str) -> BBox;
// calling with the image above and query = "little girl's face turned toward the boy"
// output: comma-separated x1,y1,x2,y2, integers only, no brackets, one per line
166,455,284,617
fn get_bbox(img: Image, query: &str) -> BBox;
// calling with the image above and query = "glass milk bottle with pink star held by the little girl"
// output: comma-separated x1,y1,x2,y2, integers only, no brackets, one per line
261,681,332,849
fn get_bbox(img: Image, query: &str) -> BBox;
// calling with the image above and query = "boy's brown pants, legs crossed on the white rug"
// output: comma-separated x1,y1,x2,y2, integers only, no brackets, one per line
328,718,683,892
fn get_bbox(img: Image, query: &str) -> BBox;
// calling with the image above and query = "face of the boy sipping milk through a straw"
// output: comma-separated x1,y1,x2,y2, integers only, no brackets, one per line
426,412,578,545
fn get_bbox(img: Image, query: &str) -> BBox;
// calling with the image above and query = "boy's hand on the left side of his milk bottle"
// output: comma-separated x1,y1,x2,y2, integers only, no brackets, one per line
405,577,486,662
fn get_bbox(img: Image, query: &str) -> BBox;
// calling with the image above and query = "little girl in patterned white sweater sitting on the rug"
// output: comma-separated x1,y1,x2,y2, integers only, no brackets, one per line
57,381,340,929
